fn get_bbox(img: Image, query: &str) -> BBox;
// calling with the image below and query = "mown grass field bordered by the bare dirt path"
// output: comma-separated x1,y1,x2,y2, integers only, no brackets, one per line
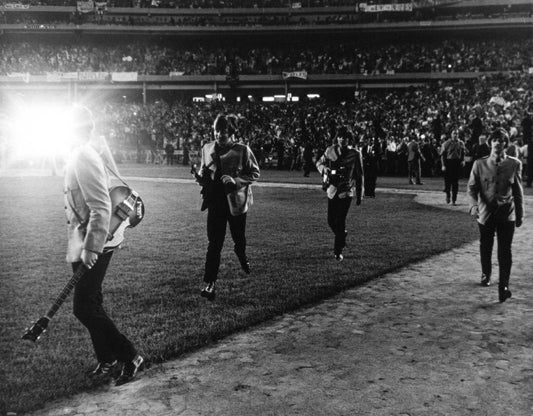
0,166,477,415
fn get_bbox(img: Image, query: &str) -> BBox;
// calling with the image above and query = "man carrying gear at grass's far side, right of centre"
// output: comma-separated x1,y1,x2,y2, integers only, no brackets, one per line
316,126,364,261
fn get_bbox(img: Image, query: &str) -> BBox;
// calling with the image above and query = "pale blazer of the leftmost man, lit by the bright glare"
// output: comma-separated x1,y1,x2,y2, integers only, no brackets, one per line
65,144,111,263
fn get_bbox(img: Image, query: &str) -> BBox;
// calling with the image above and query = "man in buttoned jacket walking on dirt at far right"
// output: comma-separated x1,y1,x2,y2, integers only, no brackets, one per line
468,128,524,302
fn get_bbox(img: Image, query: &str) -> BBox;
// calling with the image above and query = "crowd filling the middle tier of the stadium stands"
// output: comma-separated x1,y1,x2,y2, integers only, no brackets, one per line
0,35,533,75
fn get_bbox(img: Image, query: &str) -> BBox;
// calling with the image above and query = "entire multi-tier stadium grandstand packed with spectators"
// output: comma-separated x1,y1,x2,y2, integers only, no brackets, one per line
0,0,533,182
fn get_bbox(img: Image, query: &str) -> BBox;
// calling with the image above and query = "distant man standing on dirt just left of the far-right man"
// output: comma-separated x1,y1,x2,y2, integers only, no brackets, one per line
440,129,465,205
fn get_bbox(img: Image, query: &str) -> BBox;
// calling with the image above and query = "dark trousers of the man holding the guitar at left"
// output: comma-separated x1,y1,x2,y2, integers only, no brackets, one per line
72,252,137,363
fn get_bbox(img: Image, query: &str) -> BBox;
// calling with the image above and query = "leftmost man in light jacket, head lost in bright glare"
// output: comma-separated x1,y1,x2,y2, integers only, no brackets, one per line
65,107,144,385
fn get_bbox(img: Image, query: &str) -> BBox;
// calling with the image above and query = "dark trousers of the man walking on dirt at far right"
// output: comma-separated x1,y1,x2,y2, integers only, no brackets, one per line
478,220,515,286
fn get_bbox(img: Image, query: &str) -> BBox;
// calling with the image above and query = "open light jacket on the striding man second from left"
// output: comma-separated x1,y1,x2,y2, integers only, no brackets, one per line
200,141,260,215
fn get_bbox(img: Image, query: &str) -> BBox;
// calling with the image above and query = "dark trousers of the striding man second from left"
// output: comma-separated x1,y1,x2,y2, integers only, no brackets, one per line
204,197,246,283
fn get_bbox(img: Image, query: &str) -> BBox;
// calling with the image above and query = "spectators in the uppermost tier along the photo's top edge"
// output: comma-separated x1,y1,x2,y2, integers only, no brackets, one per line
0,0,533,27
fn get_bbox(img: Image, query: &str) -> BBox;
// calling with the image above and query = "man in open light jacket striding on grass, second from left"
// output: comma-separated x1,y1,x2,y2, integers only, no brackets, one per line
196,114,259,301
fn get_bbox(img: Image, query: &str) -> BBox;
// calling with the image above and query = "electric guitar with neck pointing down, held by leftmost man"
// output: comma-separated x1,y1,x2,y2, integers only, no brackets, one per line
22,186,144,342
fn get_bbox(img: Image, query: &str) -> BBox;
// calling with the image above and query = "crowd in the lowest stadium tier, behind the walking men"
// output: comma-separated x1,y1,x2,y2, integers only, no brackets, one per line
89,75,533,183
